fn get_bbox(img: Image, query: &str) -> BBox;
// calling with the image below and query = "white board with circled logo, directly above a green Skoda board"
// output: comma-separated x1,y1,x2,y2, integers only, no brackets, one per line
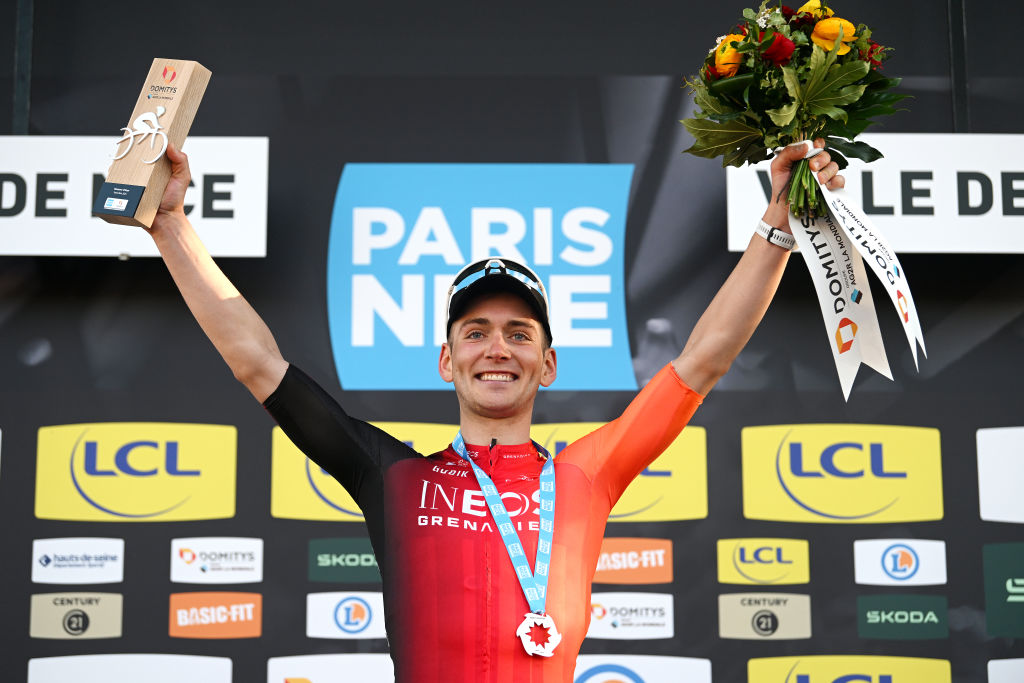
853,539,946,586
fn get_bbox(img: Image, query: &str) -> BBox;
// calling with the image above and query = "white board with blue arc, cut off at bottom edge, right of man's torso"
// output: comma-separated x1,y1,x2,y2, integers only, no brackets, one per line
572,654,711,683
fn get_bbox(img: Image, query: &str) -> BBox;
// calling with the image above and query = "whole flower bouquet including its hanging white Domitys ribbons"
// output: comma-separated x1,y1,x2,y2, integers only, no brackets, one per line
683,0,925,397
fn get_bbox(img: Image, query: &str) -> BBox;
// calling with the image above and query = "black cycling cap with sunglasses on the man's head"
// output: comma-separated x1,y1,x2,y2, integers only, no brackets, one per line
445,258,551,345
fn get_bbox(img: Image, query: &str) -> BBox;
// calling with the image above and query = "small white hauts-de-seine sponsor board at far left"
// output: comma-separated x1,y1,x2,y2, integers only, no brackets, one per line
32,538,125,584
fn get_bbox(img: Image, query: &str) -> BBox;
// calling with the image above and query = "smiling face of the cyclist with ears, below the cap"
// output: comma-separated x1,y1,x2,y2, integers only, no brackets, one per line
438,294,556,420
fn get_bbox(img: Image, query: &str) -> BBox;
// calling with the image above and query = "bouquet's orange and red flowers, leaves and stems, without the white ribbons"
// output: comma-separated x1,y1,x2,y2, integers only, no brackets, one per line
682,0,906,215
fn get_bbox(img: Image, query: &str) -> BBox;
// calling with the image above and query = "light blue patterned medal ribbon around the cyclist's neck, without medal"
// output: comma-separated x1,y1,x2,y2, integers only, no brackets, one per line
452,430,555,614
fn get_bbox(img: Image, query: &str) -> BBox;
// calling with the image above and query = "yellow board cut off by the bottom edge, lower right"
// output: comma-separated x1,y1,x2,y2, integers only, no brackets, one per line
746,654,952,683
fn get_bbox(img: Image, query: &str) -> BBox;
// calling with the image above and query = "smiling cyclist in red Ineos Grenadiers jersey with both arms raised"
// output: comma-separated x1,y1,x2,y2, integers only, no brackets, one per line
150,140,844,683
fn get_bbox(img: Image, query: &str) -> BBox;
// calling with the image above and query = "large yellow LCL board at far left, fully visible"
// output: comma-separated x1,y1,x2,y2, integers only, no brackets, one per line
36,422,237,521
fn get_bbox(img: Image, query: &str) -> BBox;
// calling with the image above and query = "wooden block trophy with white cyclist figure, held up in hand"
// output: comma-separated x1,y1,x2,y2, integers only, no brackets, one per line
92,58,210,227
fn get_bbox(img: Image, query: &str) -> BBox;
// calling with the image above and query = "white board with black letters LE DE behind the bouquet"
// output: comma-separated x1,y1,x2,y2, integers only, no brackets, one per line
726,133,1024,252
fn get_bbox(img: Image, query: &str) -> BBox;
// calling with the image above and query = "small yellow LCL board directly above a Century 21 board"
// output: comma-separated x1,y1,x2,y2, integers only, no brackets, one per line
717,539,811,586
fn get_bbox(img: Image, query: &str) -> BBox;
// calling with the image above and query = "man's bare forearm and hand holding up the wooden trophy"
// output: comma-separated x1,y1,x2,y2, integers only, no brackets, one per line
150,145,288,402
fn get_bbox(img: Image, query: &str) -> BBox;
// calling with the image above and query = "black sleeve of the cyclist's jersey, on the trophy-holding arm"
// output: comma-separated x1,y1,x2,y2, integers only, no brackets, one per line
263,366,419,537
